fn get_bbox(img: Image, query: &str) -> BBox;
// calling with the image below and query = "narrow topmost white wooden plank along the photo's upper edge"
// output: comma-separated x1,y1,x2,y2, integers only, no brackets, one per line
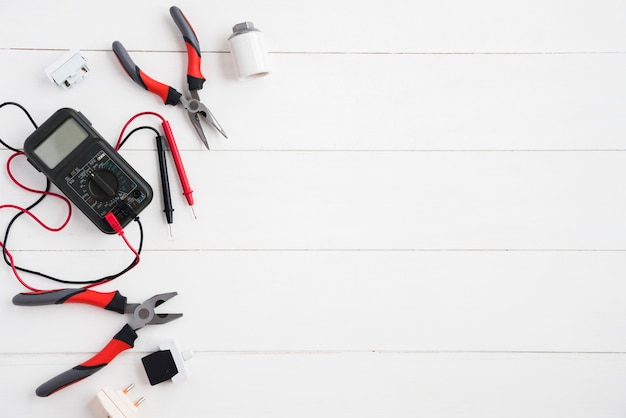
0,0,626,53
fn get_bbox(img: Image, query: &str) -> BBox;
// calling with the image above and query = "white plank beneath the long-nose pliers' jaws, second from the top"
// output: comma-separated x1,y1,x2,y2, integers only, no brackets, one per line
0,50,626,150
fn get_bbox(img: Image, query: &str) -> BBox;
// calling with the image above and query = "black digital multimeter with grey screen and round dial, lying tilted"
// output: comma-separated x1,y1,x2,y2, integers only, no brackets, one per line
24,108,153,234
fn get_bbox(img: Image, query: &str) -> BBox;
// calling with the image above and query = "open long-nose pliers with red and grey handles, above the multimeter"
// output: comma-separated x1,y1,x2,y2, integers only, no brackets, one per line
113,6,228,149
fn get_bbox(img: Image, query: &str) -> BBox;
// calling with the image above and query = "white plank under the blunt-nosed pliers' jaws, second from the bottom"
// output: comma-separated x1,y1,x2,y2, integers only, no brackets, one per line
0,251,626,357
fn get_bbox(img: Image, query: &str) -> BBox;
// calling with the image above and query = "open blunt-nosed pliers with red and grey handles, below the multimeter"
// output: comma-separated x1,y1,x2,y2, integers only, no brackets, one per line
13,288,183,397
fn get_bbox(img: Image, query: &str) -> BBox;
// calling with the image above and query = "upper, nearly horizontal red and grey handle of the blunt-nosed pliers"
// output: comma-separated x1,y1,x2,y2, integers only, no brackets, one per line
13,289,127,314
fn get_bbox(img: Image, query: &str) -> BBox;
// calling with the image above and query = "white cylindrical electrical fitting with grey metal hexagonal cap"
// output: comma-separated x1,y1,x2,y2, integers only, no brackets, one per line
228,22,270,80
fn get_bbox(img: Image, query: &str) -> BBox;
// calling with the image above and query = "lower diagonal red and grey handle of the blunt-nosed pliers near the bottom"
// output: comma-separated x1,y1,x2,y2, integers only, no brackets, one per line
35,324,137,397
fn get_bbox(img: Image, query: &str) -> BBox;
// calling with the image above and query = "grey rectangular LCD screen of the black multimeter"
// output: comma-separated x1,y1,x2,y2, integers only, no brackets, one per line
33,119,89,168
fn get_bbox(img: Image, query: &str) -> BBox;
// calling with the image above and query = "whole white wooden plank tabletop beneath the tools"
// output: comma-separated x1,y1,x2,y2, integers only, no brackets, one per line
0,0,626,418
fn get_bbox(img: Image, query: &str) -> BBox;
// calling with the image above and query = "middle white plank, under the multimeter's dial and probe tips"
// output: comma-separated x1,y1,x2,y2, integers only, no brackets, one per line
0,151,626,250
